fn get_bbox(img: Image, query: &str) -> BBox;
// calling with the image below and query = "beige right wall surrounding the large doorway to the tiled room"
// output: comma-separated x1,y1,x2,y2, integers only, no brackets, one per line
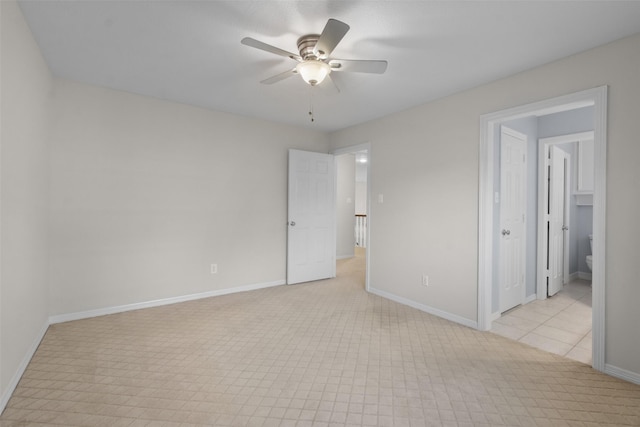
331,35,640,373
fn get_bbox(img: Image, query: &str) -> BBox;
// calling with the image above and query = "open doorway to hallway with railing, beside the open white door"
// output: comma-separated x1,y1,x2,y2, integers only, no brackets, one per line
331,143,371,291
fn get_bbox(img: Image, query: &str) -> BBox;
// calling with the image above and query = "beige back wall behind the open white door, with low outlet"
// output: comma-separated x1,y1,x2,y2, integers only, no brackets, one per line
50,80,328,315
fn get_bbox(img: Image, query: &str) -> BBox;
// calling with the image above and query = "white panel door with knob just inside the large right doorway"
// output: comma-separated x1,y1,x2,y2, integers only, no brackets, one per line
499,127,526,313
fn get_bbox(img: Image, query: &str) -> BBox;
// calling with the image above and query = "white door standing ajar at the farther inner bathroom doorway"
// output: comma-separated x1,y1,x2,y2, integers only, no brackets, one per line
547,145,569,296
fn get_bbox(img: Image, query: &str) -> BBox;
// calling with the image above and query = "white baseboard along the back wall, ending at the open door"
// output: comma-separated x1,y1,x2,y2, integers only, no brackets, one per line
49,280,286,325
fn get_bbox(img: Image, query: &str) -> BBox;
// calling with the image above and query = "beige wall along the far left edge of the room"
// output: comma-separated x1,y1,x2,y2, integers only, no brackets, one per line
0,1,51,402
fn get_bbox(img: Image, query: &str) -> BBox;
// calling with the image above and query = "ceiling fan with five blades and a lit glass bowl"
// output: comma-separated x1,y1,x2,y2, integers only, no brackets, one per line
241,19,387,86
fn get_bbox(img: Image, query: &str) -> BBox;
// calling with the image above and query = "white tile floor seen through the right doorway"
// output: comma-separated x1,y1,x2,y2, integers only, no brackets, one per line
491,280,592,365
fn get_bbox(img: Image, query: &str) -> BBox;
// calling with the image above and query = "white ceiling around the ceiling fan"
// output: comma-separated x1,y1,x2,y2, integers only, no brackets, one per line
20,0,640,131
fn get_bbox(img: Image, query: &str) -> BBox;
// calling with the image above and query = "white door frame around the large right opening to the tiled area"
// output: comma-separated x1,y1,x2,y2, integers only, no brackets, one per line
478,86,607,371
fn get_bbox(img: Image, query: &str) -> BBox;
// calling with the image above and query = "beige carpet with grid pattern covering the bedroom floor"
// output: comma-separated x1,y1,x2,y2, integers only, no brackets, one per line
0,249,640,427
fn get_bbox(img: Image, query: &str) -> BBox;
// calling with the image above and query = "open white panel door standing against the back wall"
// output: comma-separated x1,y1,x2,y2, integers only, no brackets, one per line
287,150,336,284
